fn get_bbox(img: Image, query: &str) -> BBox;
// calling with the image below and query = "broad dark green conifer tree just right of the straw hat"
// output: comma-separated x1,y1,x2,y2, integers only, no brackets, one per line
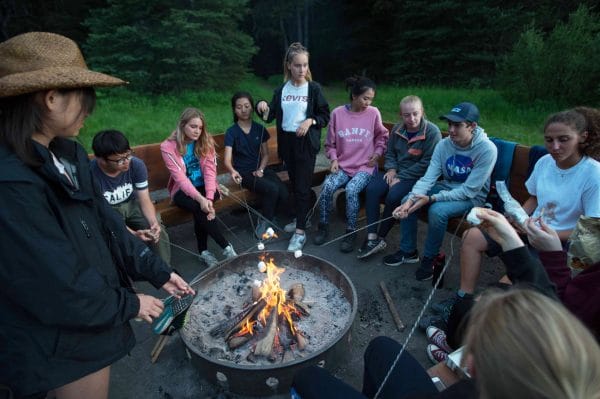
84,0,256,93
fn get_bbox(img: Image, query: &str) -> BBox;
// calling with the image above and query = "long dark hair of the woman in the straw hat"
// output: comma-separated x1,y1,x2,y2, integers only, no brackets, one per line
0,87,96,166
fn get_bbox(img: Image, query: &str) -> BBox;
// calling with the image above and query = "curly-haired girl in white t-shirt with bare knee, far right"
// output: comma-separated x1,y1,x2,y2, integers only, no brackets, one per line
458,107,600,297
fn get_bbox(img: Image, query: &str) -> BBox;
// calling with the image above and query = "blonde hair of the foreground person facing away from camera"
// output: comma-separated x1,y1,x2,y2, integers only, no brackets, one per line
465,289,600,399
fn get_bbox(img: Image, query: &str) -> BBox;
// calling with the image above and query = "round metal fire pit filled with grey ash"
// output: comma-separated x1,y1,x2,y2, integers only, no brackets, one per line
181,251,357,396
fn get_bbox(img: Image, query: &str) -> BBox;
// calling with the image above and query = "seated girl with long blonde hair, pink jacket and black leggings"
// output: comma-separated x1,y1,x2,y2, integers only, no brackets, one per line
160,108,237,266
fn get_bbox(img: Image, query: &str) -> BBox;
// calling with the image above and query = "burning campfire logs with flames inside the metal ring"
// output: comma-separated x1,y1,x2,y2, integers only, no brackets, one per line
210,255,310,363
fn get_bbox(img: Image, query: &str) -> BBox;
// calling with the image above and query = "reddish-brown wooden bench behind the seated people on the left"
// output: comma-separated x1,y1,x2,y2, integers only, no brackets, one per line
133,126,328,226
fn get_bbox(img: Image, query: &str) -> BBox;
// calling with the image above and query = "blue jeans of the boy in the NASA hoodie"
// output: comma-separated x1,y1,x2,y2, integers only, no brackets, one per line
400,184,473,258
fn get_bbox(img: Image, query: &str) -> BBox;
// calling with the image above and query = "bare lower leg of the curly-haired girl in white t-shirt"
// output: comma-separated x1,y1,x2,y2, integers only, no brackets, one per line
460,227,488,294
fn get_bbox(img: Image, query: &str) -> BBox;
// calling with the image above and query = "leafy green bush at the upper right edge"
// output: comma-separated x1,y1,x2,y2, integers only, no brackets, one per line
498,6,600,105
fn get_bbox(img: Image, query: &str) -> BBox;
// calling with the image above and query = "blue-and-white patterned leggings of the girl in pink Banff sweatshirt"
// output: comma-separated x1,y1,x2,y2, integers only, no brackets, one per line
319,170,372,230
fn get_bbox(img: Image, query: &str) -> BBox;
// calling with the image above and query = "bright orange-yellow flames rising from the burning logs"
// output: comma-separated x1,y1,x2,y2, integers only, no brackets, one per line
250,256,299,334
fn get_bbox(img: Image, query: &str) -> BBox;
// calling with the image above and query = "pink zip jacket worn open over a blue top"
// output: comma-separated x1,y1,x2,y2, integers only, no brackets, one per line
160,138,217,201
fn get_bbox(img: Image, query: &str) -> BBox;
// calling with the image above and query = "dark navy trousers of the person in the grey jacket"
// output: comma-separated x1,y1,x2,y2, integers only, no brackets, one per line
365,171,417,237
